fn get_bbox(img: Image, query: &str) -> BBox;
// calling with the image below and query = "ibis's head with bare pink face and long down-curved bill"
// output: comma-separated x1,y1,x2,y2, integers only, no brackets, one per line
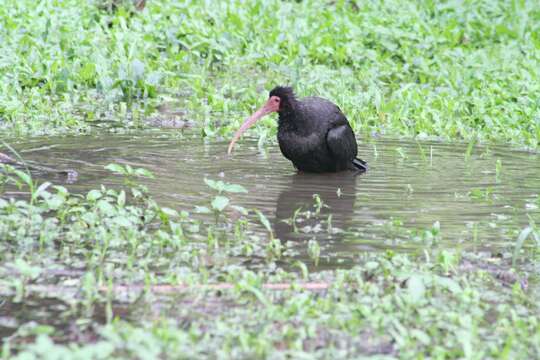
227,86,295,154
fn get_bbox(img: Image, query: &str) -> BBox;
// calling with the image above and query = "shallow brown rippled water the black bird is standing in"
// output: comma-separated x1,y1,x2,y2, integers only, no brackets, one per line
4,131,540,266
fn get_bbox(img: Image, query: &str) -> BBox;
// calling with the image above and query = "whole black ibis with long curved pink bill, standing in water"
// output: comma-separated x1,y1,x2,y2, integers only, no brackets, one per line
227,86,368,173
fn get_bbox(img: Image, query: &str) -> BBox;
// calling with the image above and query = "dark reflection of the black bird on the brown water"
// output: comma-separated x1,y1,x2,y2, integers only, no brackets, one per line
274,171,358,246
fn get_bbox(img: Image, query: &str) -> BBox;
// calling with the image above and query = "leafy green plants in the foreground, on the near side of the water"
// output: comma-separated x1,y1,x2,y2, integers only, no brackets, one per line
0,165,540,359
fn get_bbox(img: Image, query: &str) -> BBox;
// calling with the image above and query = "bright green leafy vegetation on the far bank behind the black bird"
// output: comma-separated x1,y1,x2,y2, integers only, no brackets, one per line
0,0,540,148
